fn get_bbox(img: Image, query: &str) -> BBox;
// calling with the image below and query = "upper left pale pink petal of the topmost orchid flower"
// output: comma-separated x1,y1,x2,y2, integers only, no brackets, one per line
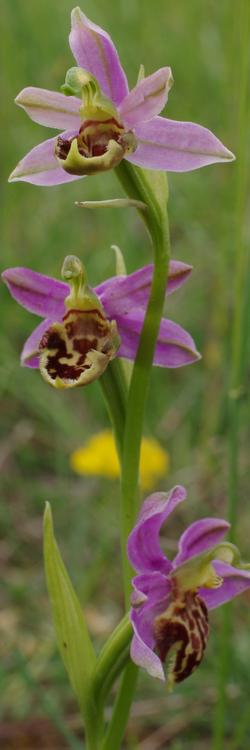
15,86,81,131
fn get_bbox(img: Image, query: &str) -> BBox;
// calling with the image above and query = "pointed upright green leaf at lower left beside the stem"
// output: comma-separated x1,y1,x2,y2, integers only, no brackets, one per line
44,503,96,713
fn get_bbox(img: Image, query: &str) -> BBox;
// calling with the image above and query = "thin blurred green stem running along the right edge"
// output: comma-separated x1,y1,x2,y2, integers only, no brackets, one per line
213,0,250,750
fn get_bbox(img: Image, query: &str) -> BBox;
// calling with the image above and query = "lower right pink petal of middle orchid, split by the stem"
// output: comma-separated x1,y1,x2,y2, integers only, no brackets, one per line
115,309,200,367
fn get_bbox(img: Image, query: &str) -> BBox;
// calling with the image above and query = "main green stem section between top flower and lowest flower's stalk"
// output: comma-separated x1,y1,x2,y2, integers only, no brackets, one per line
116,162,170,608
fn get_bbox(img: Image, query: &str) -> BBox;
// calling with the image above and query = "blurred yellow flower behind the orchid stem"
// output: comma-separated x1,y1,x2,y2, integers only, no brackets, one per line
70,430,169,490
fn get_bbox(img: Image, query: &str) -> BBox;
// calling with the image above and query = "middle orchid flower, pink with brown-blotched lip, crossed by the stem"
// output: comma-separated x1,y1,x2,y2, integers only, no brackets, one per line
2,255,200,388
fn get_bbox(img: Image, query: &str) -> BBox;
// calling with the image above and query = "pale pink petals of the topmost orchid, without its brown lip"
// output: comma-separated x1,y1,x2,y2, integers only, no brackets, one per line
9,8,235,186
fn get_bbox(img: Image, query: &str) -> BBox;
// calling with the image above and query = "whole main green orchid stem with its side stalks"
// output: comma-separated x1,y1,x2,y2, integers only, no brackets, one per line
90,163,169,750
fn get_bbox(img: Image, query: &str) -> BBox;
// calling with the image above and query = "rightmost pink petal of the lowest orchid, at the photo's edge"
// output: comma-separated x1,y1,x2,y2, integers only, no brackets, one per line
199,560,250,609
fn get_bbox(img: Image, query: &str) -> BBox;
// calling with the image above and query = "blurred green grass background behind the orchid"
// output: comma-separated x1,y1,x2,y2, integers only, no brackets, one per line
0,0,250,750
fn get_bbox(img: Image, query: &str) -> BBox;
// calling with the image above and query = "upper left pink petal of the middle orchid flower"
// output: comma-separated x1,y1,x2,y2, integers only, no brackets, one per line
2,267,69,321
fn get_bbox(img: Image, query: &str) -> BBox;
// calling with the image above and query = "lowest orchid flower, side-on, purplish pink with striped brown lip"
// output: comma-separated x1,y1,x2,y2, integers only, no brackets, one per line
128,486,250,689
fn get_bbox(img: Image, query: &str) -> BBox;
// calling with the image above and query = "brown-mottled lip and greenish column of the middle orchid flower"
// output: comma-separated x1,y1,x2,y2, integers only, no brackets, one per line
39,255,120,388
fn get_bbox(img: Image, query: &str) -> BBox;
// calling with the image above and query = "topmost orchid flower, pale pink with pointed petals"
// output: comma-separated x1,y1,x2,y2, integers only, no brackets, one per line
9,8,234,185
